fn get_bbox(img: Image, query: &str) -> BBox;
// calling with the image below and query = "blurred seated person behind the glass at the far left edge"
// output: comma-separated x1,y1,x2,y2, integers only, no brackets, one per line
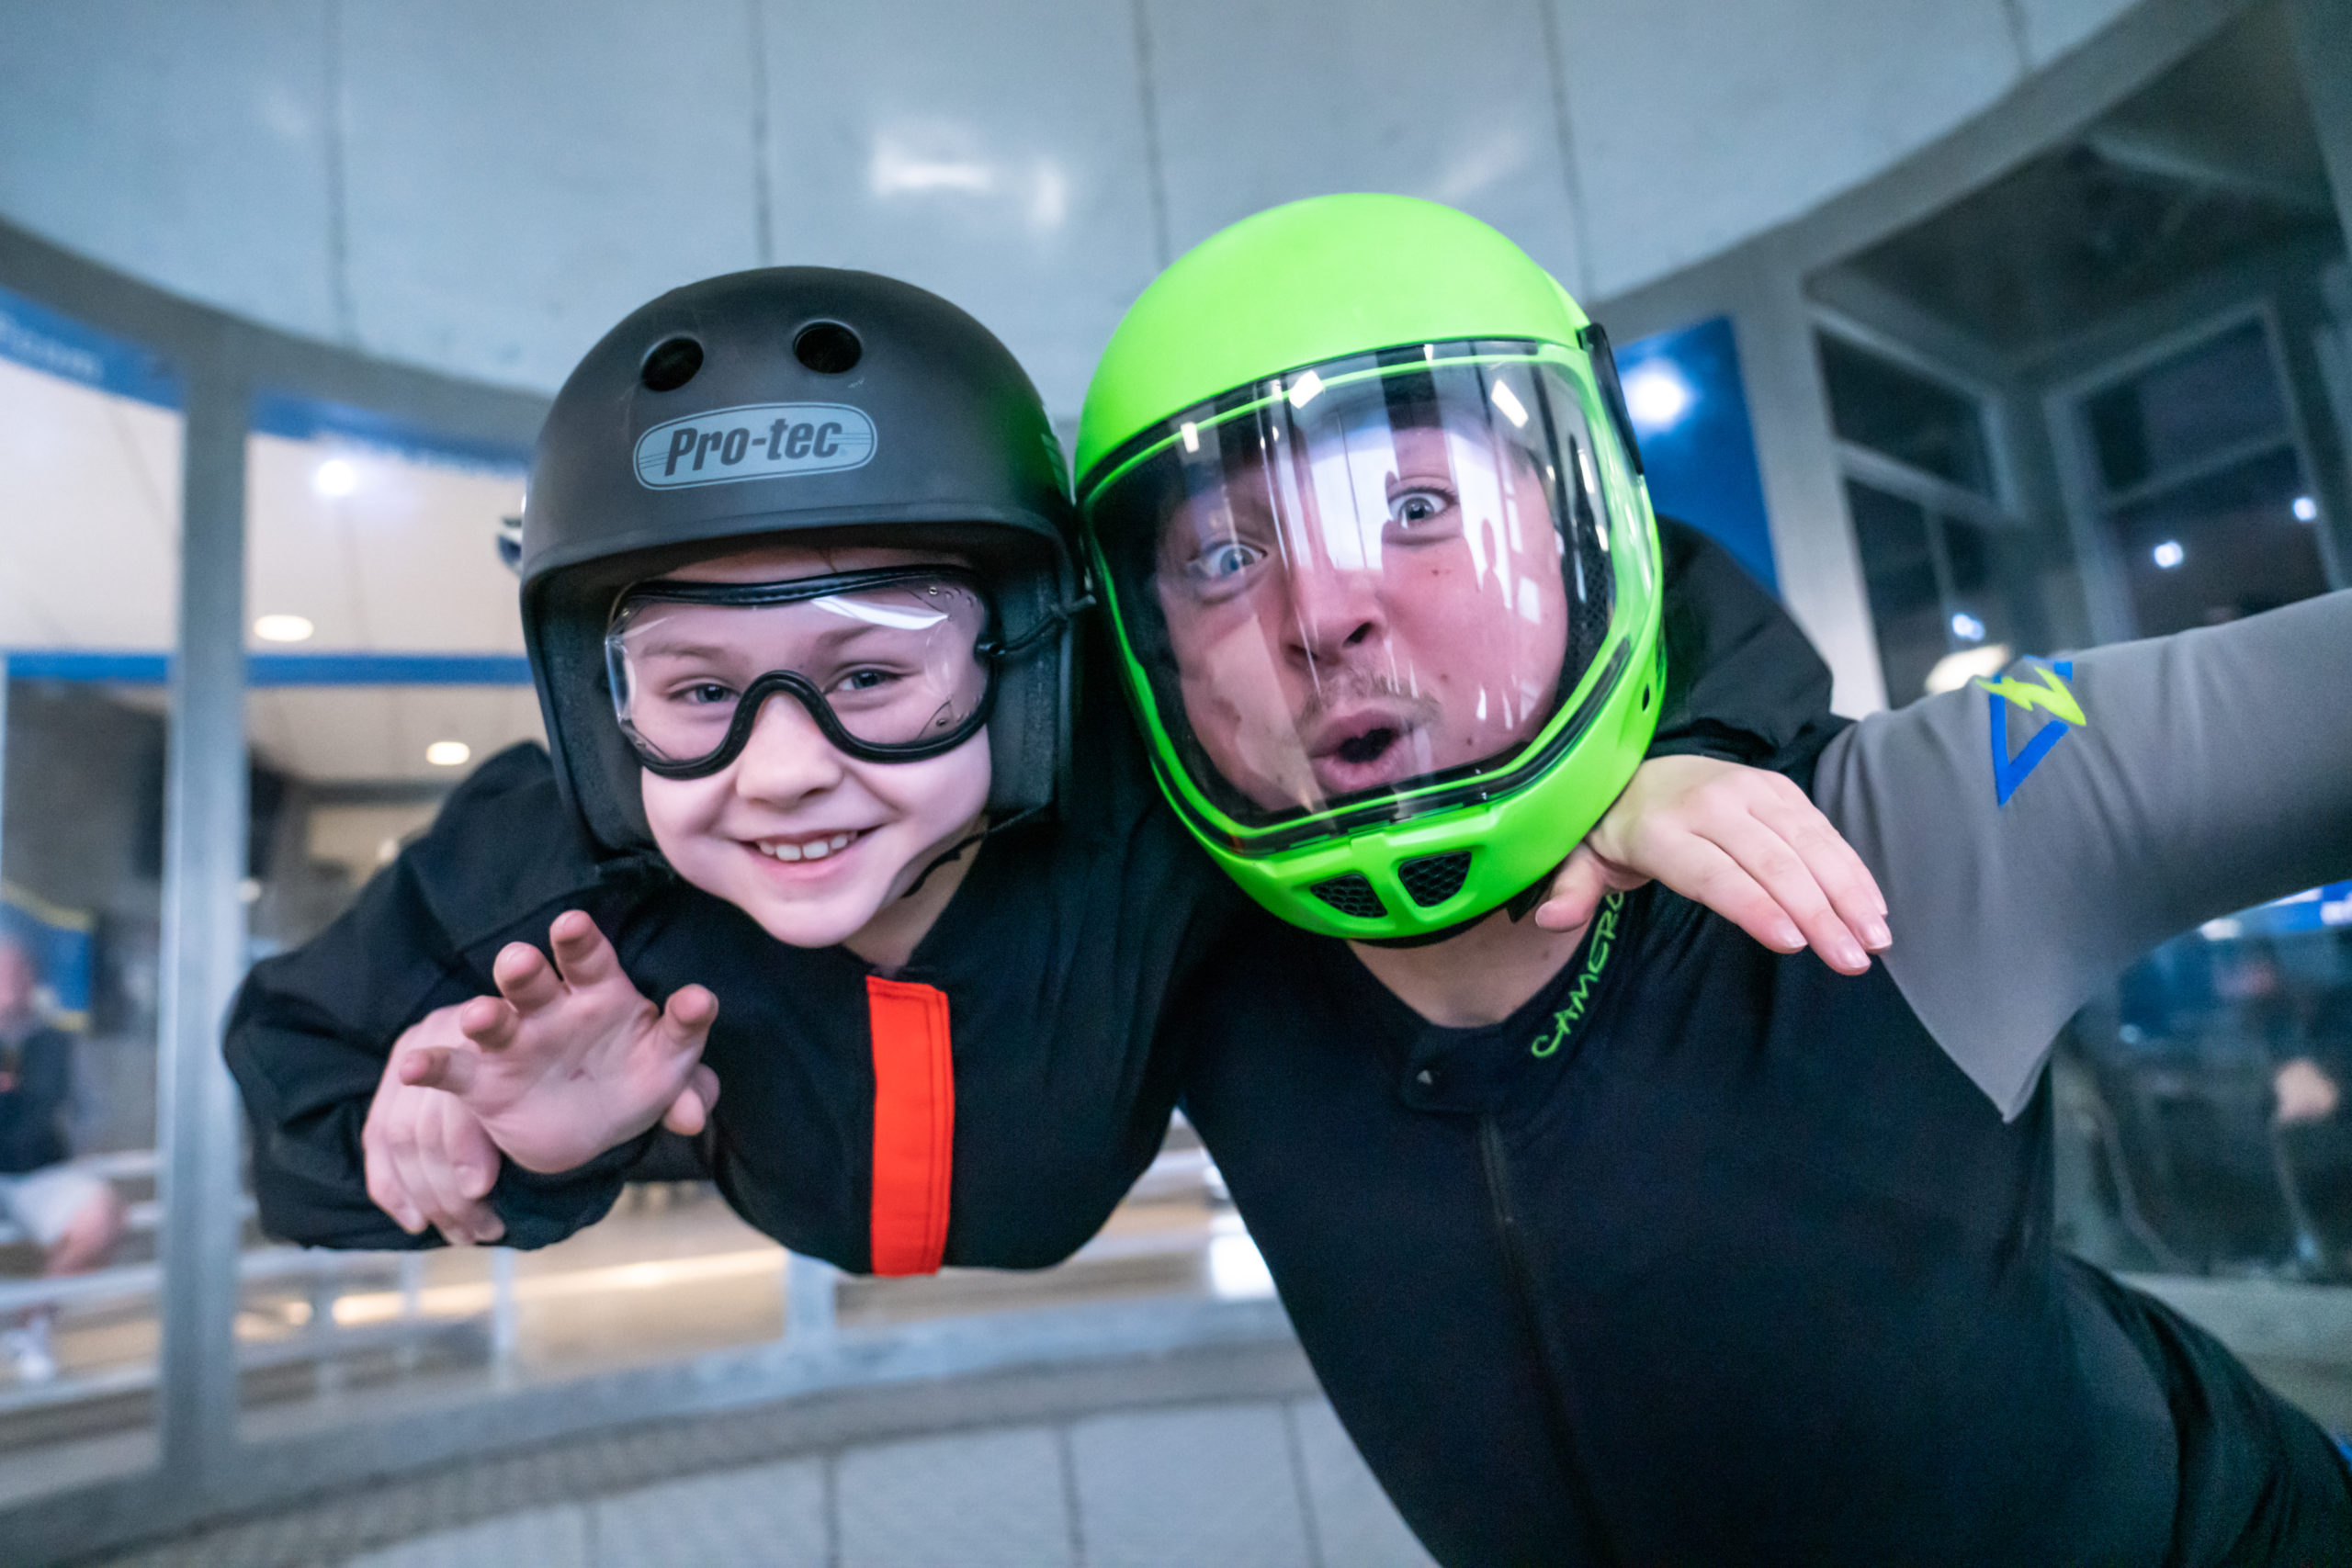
0,933,122,1382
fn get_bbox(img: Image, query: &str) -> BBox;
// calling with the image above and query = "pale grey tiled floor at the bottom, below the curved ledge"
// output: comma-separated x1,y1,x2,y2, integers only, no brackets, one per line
305,1399,1430,1568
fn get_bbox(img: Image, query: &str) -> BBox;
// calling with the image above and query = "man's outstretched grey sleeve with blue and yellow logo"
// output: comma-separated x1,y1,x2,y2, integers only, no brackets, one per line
1814,590,2352,1117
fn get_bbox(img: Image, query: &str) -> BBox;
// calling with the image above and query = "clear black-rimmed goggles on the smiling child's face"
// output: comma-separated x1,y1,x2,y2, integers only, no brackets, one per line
605,571,990,773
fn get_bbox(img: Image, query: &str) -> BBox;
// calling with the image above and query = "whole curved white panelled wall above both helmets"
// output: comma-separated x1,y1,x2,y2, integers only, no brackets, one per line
0,0,2131,413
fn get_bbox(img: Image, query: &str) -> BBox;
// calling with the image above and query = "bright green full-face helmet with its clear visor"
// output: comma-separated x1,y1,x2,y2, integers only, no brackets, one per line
1077,195,1663,941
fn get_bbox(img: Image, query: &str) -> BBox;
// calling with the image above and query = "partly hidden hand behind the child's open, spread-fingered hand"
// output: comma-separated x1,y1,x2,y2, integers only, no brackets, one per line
360,1006,505,1246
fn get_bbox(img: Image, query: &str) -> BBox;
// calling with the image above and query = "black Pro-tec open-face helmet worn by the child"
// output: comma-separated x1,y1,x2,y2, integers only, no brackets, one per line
520,268,1077,849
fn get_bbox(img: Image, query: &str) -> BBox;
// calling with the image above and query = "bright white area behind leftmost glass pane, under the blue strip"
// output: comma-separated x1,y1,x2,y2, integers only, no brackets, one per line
0,360,181,651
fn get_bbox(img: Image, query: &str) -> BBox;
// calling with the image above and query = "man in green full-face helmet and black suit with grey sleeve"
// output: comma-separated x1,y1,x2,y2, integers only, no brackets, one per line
1080,195,2352,1565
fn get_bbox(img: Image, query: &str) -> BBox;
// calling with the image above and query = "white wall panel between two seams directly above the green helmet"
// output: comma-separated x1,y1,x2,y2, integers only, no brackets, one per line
1146,0,1580,289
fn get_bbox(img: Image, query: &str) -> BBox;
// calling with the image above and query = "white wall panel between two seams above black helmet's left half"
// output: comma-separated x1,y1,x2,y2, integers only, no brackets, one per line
344,0,760,388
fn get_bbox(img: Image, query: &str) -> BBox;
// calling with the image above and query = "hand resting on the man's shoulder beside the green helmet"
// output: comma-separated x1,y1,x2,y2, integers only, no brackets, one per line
1536,757,1894,976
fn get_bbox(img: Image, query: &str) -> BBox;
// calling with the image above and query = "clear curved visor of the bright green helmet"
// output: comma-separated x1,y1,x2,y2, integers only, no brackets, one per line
1089,344,1646,828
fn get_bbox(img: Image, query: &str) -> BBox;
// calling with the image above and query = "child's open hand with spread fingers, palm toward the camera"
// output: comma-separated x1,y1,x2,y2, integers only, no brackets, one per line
390,909,719,1170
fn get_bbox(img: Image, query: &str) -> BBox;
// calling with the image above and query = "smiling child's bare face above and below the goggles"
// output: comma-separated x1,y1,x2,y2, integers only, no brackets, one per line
639,546,990,947
